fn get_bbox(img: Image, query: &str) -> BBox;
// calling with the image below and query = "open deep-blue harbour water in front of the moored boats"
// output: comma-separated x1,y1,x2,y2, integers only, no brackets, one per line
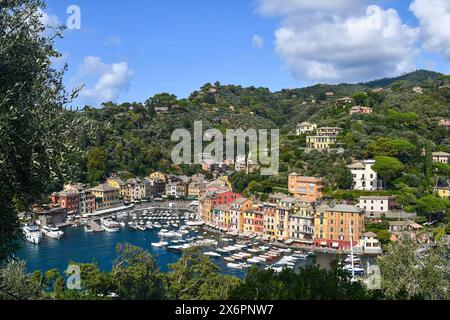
17,227,334,278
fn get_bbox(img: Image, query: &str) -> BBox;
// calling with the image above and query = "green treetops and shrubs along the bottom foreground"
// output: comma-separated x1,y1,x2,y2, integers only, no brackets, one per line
0,241,449,300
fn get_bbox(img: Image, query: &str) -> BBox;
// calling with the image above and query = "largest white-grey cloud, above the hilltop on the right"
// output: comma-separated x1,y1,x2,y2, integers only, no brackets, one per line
259,0,418,82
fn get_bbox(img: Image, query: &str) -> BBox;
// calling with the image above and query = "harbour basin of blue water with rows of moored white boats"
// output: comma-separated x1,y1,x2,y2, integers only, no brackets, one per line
18,208,374,278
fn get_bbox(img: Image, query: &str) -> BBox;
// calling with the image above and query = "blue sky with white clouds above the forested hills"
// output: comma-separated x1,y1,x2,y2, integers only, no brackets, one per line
45,0,450,104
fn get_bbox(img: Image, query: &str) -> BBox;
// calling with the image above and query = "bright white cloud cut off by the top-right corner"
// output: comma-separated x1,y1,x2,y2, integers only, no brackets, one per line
410,0,450,59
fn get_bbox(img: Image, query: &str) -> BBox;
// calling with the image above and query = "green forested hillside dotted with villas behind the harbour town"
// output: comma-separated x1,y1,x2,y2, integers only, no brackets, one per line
73,71,450,195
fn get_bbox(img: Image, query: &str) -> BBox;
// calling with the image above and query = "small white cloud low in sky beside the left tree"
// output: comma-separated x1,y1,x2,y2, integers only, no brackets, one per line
79,56,133,103
